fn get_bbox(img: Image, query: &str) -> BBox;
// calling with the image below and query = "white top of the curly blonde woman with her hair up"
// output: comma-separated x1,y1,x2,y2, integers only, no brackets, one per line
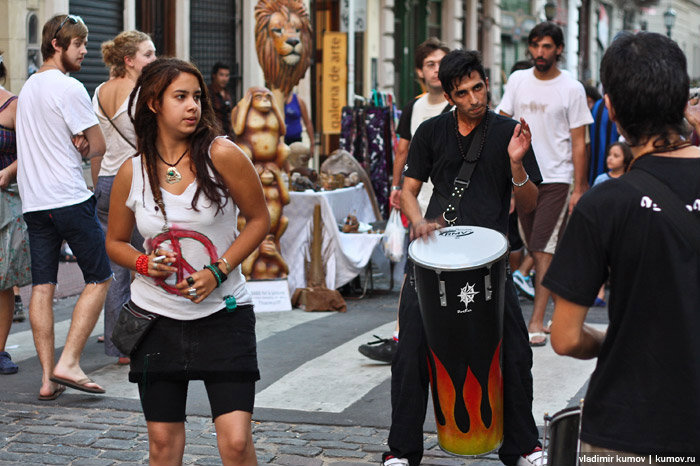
92,83,136,176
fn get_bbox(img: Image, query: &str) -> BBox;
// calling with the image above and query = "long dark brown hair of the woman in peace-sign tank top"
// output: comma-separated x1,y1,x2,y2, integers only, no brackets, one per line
129,58,229,214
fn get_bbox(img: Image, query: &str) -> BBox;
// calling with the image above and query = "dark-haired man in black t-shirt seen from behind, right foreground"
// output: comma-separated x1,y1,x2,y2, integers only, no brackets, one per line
543,32,700,458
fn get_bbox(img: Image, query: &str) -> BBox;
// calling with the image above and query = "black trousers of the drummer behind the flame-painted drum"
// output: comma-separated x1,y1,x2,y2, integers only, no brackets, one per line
384,266,539,466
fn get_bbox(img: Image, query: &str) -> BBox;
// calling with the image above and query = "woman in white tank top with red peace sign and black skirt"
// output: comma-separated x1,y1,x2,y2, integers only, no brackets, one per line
107,58,270,465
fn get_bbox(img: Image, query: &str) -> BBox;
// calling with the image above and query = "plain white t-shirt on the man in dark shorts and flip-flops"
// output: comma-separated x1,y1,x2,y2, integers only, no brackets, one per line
17,70,98,212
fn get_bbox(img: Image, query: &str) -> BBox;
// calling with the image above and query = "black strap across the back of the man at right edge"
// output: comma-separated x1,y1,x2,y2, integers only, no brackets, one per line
620,168,700,254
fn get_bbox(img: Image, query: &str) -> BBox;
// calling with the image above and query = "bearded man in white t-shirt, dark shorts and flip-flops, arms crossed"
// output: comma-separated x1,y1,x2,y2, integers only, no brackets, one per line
17,15,112,400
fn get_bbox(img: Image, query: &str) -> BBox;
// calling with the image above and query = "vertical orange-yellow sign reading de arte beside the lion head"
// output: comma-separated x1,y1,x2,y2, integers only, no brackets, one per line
321,31,348,134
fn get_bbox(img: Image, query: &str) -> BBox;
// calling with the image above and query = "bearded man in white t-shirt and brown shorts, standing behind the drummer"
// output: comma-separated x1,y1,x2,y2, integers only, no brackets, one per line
498,22,593,346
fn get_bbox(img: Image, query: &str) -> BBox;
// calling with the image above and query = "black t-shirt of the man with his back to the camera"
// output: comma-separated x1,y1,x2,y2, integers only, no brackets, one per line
543,155,700,459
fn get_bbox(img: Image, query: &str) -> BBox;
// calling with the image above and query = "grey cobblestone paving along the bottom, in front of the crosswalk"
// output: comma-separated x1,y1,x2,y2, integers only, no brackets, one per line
0,403,500,466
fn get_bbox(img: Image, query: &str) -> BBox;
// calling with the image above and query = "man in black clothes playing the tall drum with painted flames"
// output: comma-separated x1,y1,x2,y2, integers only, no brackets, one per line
383,50,544,466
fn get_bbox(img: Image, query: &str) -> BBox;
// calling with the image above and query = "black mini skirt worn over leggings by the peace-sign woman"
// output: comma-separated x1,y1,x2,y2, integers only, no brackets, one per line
129,303,260,383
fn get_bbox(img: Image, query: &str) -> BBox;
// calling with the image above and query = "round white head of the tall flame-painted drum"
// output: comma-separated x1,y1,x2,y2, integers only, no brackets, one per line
408,226,508,271
